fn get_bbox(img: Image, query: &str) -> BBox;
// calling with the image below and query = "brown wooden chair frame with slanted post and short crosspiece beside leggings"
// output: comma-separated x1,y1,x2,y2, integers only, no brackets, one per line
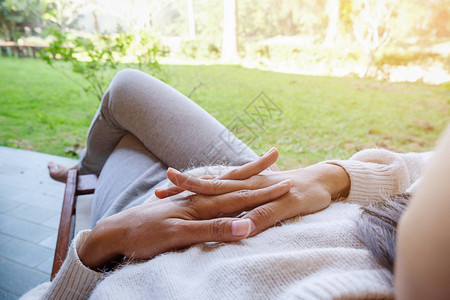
50,170,98,280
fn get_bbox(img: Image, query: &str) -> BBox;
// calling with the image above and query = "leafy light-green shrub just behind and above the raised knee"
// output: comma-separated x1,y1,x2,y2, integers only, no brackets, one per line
42,28,163,100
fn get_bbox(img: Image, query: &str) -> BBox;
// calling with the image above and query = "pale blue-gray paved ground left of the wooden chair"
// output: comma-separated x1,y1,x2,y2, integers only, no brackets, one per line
0,147,76,299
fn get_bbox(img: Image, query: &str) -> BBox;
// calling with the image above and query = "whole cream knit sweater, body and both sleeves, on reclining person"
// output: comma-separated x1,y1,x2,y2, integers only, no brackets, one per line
23,149,431,299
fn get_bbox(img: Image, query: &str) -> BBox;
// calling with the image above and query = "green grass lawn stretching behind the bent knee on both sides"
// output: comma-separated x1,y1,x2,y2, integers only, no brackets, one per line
0,58,450,169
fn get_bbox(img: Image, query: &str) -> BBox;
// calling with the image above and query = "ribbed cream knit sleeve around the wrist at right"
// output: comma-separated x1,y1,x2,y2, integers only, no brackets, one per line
325,149,433,205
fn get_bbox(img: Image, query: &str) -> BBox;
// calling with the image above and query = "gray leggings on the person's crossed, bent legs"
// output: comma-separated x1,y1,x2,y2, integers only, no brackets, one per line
79,70,257,226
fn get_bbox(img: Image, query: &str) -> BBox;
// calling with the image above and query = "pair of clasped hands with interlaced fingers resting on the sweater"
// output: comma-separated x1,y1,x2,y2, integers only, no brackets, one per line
78,148,348,270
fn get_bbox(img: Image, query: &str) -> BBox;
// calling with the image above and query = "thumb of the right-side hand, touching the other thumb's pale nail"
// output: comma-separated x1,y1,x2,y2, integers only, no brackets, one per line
243,195,300,236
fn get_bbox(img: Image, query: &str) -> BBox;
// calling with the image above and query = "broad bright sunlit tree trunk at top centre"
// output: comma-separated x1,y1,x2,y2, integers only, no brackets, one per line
222,0,239,62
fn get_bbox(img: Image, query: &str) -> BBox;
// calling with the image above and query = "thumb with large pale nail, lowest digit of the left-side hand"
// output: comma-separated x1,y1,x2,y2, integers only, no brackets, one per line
179,218,252,246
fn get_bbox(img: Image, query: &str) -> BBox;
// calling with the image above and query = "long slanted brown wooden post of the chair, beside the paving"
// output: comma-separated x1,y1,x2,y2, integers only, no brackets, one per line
50,170,77,280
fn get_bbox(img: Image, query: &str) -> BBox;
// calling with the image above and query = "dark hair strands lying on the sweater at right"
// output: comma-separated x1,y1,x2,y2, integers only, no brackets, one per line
357,193,411,273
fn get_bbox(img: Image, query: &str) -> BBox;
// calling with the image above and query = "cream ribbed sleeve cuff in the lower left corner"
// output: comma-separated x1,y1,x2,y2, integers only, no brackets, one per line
21,230,106,300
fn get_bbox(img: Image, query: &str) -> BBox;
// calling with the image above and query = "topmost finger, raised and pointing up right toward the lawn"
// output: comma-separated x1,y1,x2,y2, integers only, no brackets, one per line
219,147,278,180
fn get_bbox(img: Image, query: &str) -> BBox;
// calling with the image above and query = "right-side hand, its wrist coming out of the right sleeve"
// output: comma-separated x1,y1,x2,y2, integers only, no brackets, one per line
158,150,350,236
